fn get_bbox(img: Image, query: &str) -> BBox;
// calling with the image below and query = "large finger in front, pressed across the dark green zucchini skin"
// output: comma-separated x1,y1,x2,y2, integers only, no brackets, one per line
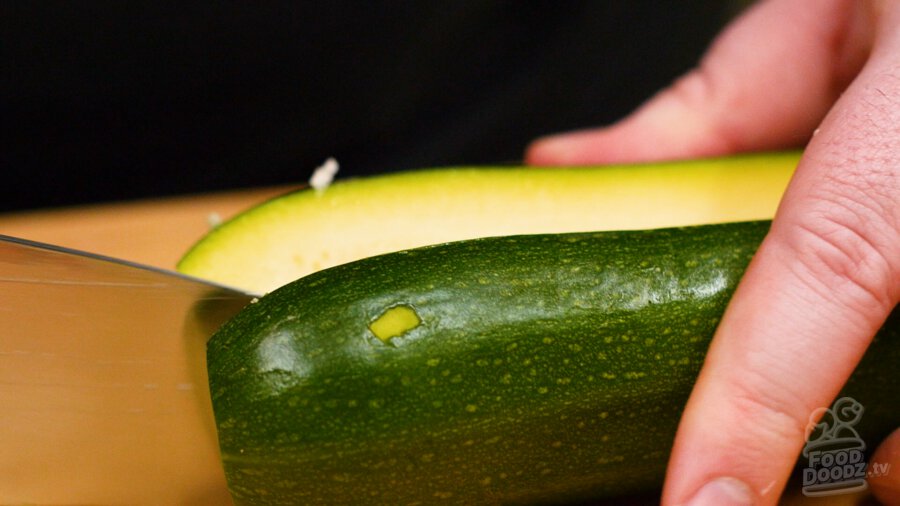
664,3,900,504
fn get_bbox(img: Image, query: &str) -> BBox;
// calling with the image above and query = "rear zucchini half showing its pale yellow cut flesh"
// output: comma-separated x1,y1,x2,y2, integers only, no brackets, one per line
178,153,800,293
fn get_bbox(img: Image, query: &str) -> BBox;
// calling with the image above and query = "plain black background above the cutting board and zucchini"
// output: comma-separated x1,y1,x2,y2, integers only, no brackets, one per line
0,0,740,211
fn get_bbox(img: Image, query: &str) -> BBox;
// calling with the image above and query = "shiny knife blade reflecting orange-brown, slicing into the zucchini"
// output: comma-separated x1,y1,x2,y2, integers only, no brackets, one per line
0,235,252,505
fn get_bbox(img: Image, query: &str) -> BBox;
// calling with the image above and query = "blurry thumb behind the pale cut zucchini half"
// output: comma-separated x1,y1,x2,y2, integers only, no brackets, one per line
525,0,871,165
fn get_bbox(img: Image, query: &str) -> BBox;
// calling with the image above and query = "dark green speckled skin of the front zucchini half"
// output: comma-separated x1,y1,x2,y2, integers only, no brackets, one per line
207,222,900,505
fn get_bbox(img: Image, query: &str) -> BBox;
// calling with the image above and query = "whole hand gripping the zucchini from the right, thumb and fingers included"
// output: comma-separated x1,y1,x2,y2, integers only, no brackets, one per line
526,0,900,505
